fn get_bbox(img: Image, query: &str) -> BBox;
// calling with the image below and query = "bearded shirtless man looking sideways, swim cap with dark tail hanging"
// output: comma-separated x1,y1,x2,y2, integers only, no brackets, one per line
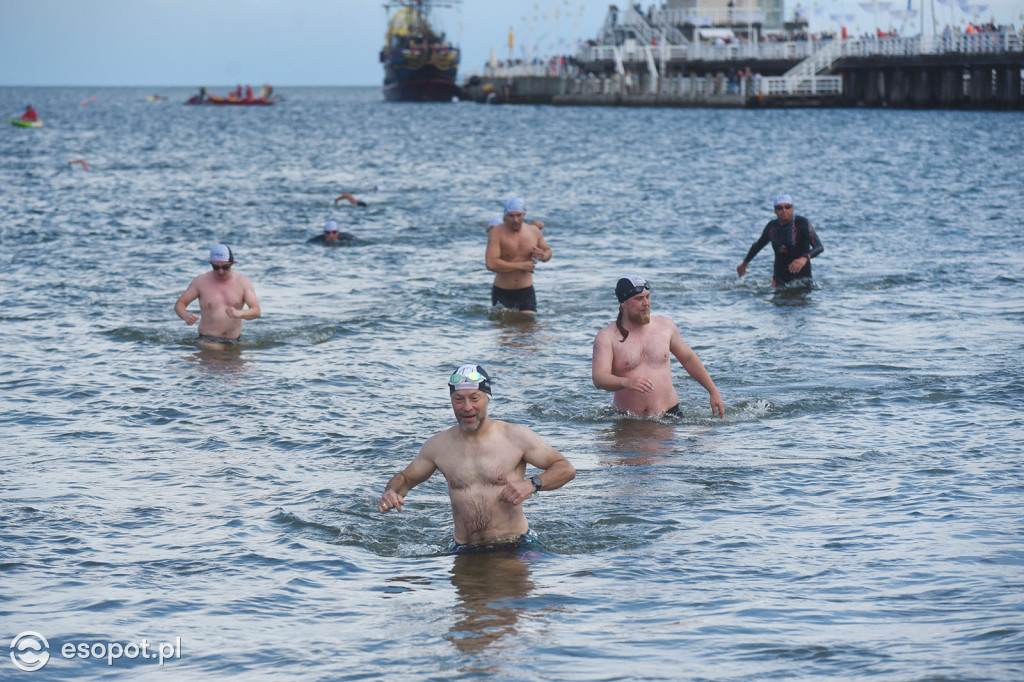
592,274,725,418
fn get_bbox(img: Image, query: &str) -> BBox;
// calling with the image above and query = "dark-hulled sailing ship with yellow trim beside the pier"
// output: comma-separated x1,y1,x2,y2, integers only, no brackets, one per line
381,0,459,101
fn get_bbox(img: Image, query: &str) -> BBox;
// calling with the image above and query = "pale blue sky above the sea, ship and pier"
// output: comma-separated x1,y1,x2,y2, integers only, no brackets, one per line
0,0,1024,87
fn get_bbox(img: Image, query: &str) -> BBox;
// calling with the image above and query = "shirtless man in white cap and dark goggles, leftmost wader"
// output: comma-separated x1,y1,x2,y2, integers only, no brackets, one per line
174,244,260,343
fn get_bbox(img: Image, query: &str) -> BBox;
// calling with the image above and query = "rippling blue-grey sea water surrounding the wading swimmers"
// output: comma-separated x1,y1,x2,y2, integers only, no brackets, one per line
0,88,1024,680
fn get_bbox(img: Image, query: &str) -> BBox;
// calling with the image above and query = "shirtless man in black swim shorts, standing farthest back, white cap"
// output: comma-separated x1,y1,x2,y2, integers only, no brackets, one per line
485,197,551,314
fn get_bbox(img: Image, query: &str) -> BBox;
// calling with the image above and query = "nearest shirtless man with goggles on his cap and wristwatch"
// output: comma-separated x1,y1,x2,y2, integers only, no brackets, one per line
377,365,575,553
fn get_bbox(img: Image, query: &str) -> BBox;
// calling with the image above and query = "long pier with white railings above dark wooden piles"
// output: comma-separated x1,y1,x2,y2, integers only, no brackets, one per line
463,33,1024,111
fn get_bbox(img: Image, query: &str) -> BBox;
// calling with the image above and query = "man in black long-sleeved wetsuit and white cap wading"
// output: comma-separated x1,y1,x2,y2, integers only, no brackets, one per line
736,195,825,287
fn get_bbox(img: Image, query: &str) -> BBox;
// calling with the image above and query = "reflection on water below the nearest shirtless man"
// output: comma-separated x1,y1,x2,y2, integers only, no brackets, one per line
445,552,534,653
